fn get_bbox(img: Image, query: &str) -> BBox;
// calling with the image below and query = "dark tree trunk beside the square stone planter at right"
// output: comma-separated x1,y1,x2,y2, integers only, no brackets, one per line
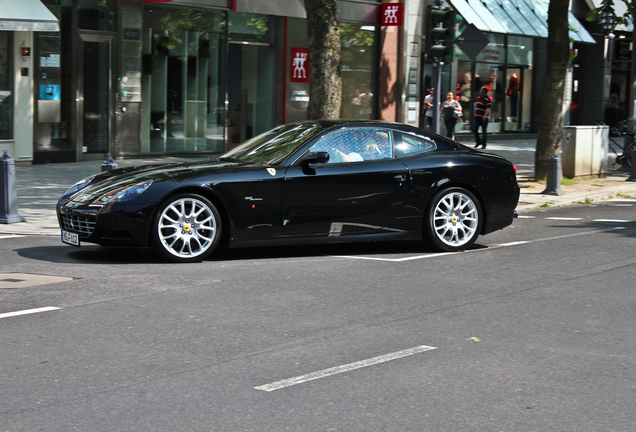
534,0,570,181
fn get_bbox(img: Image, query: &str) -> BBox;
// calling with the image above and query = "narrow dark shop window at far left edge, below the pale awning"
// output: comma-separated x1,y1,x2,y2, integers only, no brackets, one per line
0,31,13,139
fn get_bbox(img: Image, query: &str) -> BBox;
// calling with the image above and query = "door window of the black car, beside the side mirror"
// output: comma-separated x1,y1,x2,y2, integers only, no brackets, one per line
310,128,393,163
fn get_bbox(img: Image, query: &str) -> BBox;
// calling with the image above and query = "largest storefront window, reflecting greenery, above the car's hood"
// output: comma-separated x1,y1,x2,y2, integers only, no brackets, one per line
141,4,226,153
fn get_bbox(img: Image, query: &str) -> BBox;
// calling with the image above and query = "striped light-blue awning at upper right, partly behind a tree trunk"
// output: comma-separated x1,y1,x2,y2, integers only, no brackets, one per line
450,0,595,43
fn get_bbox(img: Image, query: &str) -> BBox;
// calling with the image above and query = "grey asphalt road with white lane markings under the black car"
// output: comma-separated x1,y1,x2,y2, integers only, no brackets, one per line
0,200,636,432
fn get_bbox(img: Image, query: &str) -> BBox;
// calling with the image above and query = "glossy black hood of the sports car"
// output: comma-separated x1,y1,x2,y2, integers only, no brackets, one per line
61,160,255,203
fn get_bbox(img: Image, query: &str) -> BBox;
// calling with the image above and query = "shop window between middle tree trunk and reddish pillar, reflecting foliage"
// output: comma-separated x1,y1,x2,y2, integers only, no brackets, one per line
340,24,377,119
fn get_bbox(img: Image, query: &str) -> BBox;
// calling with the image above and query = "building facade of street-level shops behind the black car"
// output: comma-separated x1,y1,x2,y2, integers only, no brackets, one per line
0,0,629,163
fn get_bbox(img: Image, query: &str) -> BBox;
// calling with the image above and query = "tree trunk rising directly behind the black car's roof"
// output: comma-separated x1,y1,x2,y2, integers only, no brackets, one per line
305,0,342,119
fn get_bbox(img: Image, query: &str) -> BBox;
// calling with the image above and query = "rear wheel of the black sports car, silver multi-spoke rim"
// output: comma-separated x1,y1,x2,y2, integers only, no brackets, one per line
423,187,482,252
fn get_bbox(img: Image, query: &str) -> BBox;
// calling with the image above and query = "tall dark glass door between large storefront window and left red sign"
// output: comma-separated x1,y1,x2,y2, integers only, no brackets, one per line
227,42,276,148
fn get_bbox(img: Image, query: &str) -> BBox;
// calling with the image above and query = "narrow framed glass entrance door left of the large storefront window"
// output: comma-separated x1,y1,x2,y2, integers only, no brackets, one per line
77,34,116,160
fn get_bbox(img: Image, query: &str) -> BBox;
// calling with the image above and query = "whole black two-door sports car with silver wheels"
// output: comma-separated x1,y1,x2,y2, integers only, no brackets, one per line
57,120,519,262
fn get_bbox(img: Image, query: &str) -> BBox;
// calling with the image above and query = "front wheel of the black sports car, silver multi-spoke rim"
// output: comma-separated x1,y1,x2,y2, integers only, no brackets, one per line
151,194,221,263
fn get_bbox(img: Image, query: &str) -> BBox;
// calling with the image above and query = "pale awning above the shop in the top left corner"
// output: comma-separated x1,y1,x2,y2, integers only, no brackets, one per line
0,0,60,31
